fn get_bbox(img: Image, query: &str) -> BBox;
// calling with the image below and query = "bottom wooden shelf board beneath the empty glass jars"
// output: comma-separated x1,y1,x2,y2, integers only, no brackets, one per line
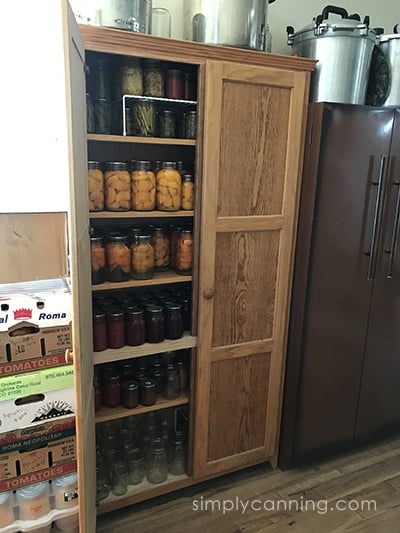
97,474,193,515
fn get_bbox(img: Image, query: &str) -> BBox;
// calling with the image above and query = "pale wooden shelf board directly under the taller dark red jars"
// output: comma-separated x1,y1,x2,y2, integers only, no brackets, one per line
93,332,197,365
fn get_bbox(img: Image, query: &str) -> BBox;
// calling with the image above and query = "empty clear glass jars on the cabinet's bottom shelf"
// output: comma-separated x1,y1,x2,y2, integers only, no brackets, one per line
96,413,187,502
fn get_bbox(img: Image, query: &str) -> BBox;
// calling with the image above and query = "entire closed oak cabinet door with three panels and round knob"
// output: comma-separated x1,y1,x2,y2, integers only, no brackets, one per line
193,61,308,477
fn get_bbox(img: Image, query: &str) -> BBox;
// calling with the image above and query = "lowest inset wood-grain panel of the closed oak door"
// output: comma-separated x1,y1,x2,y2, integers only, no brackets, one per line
208,353,270,461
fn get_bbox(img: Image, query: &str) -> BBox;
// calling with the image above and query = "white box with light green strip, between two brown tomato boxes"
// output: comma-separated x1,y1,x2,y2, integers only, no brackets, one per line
0,365,75,432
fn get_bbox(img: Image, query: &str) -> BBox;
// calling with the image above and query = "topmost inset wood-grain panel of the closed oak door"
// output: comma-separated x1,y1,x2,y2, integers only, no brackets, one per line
218,80,290,216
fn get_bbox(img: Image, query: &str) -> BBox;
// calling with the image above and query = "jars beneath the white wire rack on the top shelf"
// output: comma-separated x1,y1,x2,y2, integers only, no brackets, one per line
86,94,197,139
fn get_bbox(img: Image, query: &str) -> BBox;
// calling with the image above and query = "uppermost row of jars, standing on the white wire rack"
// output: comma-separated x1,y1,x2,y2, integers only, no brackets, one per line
86,54,196,101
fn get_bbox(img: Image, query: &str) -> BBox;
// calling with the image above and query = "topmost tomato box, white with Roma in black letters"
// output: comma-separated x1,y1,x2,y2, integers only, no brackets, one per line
0,278,72,376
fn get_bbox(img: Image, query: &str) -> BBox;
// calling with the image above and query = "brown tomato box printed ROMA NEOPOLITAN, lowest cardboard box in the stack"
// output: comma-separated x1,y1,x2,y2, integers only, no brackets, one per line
0,417,76,492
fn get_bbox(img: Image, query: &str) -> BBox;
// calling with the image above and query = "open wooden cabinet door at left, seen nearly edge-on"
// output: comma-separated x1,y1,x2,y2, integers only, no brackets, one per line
62,1,96,533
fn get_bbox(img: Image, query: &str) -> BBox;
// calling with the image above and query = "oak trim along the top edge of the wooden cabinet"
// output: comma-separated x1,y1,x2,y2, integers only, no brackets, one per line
79,24,316,71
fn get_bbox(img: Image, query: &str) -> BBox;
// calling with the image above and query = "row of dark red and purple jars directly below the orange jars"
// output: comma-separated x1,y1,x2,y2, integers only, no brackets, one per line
93,286,191,352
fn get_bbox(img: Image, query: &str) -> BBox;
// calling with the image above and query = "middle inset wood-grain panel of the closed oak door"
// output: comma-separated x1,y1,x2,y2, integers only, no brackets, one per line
212,231,280,346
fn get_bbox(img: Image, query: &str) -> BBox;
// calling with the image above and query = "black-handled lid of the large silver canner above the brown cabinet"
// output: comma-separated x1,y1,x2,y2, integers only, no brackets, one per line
286,6,377,45
